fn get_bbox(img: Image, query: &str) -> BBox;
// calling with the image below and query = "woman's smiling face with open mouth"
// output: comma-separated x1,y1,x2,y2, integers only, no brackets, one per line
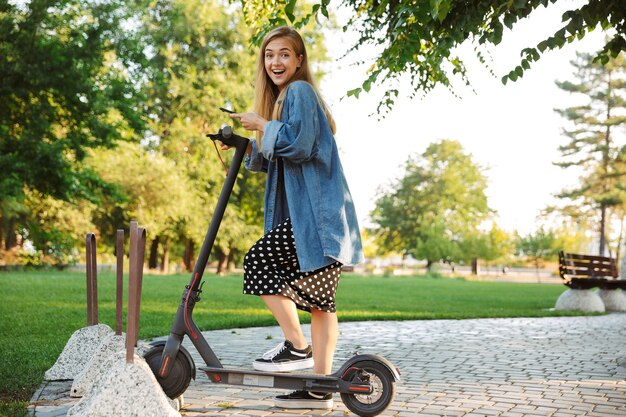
264,37,302,90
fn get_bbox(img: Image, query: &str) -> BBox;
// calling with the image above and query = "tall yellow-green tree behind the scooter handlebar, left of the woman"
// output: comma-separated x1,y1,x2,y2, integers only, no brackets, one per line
136,0,326,273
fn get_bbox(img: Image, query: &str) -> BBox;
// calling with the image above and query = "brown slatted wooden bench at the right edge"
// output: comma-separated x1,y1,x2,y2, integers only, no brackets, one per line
559,251,626,290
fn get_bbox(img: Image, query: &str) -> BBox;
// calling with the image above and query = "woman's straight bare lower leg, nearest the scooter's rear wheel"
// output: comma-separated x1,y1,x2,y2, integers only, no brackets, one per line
311,309,339,375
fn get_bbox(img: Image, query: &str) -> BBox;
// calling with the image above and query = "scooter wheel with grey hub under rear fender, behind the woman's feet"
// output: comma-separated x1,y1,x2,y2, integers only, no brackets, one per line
341,360,396,417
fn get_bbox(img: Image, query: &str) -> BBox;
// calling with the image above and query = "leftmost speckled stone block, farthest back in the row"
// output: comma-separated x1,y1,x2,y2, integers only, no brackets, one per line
44,324,114,381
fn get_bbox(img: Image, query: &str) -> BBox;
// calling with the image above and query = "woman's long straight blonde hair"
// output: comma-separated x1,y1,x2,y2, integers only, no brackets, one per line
254,26,336,145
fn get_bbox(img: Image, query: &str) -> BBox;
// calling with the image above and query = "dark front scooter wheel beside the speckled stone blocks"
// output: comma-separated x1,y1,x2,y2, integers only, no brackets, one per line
143,345,192,399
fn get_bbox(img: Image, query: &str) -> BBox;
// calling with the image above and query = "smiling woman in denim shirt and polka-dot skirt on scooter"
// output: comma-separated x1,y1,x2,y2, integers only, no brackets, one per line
225,27,363,408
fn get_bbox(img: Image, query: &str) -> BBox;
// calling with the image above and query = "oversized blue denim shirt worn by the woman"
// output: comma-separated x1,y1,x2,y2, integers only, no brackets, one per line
245,81,363,271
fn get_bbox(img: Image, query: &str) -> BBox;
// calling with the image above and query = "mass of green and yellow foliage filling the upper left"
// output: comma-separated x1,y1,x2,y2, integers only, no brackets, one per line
0,0,264,262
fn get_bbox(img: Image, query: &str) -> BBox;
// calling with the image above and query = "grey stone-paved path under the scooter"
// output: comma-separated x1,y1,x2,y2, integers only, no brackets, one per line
29,313,626,417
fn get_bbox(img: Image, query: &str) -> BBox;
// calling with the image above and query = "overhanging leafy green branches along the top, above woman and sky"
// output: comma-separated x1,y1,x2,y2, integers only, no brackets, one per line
242,0,626,111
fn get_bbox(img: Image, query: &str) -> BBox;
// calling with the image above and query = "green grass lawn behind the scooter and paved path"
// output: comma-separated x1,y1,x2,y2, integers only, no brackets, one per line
0,271,576,416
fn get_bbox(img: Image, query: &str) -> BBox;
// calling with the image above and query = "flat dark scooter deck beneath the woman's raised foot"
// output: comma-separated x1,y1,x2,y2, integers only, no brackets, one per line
198,367,340,392
